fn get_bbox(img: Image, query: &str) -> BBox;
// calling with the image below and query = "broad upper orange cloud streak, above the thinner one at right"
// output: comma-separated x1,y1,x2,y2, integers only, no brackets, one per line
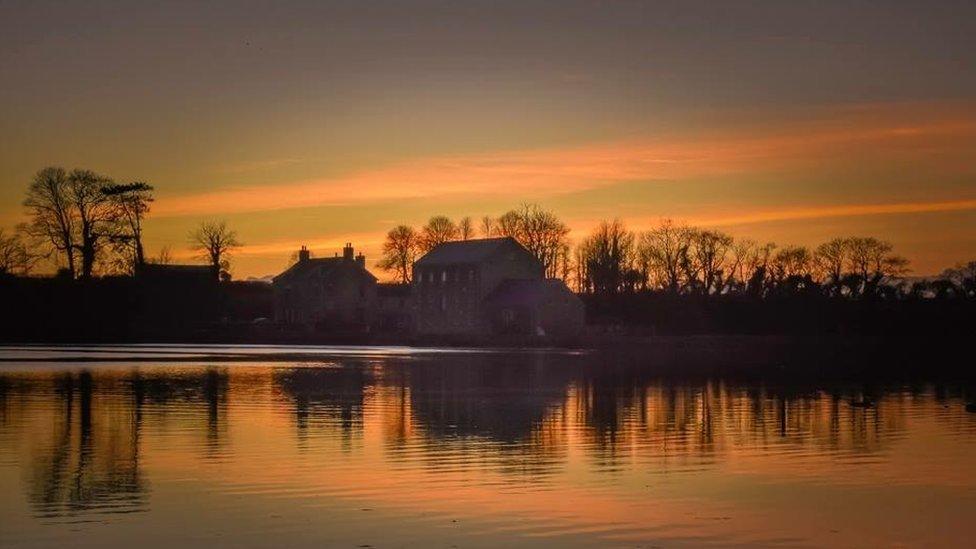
154,104,976,217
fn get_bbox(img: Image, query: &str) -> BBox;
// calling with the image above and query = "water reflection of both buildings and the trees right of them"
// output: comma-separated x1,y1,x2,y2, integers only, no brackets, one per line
266,354,944,477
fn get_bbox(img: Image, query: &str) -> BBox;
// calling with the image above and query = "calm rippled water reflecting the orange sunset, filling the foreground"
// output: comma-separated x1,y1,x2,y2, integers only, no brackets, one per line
0,346,976,547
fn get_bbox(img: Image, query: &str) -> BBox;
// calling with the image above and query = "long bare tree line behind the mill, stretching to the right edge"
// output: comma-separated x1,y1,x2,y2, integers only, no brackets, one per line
377,204,976,299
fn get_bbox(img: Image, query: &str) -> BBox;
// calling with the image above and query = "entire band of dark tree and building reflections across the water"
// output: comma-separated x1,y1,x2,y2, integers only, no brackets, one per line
0,354,976,519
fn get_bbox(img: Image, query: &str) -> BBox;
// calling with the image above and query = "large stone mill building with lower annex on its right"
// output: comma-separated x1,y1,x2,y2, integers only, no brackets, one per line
413,237,584,337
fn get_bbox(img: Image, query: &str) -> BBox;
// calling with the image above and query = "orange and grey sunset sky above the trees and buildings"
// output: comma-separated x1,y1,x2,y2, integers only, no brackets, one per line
0,0,976,278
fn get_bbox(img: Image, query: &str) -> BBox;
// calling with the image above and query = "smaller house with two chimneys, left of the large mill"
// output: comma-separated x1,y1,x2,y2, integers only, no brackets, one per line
273,244,376,329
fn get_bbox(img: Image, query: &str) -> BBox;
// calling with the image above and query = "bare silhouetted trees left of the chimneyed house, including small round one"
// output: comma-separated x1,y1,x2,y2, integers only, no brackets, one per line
0,166,241,279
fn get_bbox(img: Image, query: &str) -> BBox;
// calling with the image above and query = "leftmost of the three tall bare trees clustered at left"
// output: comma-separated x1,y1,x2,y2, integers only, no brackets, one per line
24,166,78,278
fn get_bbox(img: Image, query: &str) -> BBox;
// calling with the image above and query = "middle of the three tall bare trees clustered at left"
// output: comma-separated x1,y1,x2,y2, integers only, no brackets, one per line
68,170,116,278
